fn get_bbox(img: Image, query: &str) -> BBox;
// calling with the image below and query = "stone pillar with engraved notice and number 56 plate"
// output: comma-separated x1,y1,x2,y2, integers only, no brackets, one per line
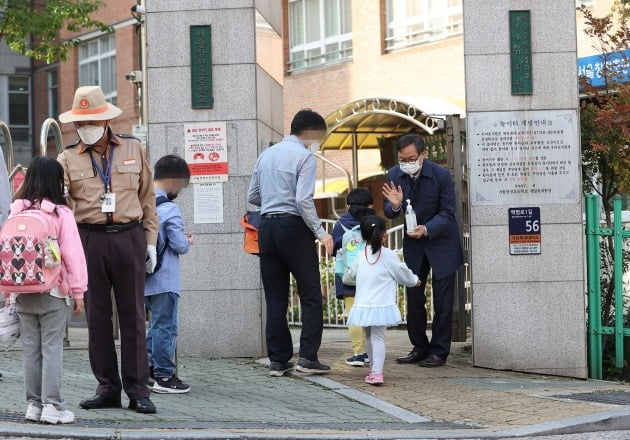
464,0,587,378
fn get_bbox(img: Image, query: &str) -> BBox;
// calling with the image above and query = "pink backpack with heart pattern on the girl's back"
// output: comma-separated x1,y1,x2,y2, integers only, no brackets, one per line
0,205,61,294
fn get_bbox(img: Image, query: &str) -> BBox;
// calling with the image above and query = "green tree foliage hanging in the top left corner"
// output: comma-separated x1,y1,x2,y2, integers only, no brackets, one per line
0,0,111,63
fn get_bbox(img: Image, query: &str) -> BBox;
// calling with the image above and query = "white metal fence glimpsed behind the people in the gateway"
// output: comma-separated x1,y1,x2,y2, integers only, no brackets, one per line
288,220,433,327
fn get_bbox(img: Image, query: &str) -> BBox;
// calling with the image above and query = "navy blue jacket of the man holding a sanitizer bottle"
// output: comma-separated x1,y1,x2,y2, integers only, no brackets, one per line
384,160,463,279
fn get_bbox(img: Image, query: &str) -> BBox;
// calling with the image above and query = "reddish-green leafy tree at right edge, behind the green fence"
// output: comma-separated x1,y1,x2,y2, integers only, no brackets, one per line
578,5,630,325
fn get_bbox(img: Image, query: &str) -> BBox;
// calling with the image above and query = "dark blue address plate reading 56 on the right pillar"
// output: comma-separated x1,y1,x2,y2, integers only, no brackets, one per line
508,207,542,255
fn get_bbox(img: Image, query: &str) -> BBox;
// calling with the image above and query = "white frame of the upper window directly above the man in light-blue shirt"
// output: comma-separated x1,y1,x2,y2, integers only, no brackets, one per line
288,0,353,73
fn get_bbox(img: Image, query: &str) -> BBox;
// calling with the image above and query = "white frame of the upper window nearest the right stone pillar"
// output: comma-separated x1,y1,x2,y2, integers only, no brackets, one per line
384,0,464,52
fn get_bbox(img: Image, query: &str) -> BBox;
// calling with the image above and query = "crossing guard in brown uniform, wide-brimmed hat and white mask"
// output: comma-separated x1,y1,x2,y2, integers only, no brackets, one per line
58,86,158,413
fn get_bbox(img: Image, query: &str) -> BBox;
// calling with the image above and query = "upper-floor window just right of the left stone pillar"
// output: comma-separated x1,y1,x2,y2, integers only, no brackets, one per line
289,0,352,71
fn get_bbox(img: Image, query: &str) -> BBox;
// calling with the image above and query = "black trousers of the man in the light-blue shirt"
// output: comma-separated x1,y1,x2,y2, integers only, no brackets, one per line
258,216,324,362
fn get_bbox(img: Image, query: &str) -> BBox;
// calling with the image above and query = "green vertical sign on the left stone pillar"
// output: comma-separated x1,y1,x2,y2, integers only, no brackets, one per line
190,25,212,108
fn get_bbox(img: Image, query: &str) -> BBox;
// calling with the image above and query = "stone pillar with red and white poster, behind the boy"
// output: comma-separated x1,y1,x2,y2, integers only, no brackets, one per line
146,0,283,357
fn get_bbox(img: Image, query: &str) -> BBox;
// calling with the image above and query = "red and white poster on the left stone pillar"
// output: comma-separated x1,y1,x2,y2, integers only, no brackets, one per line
184,122,228,183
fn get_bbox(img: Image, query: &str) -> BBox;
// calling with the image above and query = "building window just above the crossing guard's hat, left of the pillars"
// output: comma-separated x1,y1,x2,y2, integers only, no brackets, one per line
79,34,117,104
